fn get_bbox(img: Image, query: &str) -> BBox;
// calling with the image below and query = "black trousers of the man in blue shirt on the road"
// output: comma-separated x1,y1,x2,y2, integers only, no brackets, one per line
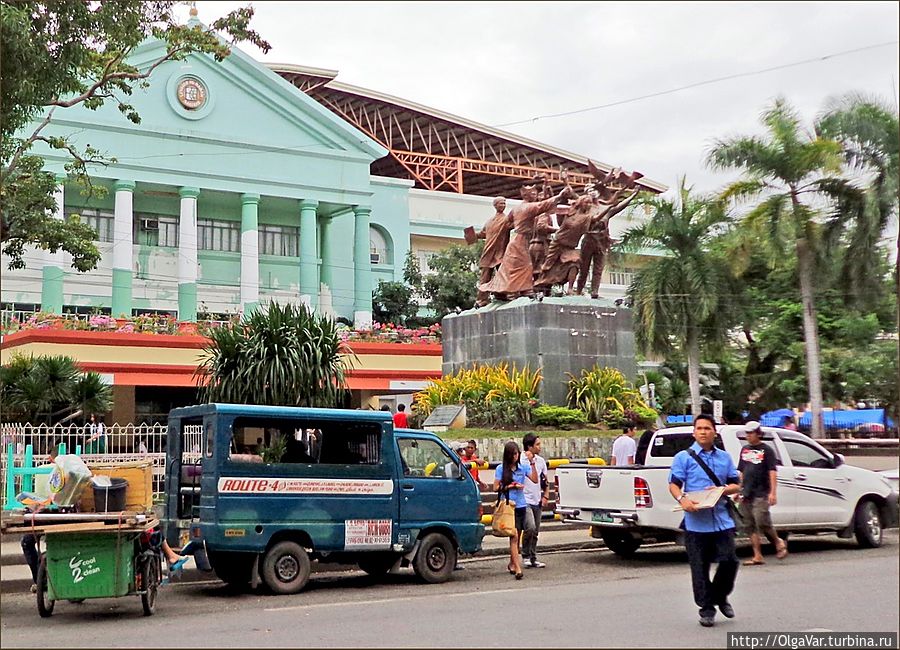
684,528,738,616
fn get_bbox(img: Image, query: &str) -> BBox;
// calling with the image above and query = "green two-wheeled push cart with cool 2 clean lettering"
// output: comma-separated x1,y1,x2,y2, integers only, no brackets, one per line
3,513,163,618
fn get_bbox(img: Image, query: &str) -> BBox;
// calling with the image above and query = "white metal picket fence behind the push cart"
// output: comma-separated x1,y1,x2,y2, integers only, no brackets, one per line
0,422,203,505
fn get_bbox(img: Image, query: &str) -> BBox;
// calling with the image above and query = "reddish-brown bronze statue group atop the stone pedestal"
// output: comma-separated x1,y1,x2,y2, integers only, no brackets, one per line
466,161,643,307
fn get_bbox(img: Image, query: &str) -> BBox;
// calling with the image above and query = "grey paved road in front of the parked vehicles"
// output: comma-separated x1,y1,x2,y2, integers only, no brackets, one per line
0,530,900,648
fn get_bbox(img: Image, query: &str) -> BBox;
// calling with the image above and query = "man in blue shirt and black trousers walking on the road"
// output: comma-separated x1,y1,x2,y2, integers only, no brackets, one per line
669,413,741,627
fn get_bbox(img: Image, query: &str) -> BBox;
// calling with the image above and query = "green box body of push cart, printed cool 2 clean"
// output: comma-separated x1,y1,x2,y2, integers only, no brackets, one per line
47,533,140,600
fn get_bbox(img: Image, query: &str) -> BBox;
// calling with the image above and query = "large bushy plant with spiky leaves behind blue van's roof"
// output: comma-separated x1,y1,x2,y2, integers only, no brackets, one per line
198,302,348,407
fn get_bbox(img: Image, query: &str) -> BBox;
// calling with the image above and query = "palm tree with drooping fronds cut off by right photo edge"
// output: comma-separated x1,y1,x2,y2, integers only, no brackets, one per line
816,93,900,327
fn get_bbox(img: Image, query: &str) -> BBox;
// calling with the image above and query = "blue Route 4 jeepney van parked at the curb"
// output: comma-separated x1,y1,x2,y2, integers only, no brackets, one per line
164,404,484,594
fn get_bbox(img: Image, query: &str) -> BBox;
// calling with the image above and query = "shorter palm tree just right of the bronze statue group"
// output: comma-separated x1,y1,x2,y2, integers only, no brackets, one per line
618,178,726,415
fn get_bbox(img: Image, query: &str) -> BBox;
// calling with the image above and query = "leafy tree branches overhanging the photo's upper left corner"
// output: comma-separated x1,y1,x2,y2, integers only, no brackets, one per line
0,0,270,271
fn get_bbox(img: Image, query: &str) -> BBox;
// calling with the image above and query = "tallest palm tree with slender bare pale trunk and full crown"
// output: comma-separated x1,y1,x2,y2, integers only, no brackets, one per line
707,98,862,438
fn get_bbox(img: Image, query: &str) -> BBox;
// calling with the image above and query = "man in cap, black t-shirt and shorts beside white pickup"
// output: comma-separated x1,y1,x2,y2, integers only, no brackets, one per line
738,420,787,566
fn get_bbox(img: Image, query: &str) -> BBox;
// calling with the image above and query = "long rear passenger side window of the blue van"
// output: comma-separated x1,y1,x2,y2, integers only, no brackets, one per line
229,418,381,465
